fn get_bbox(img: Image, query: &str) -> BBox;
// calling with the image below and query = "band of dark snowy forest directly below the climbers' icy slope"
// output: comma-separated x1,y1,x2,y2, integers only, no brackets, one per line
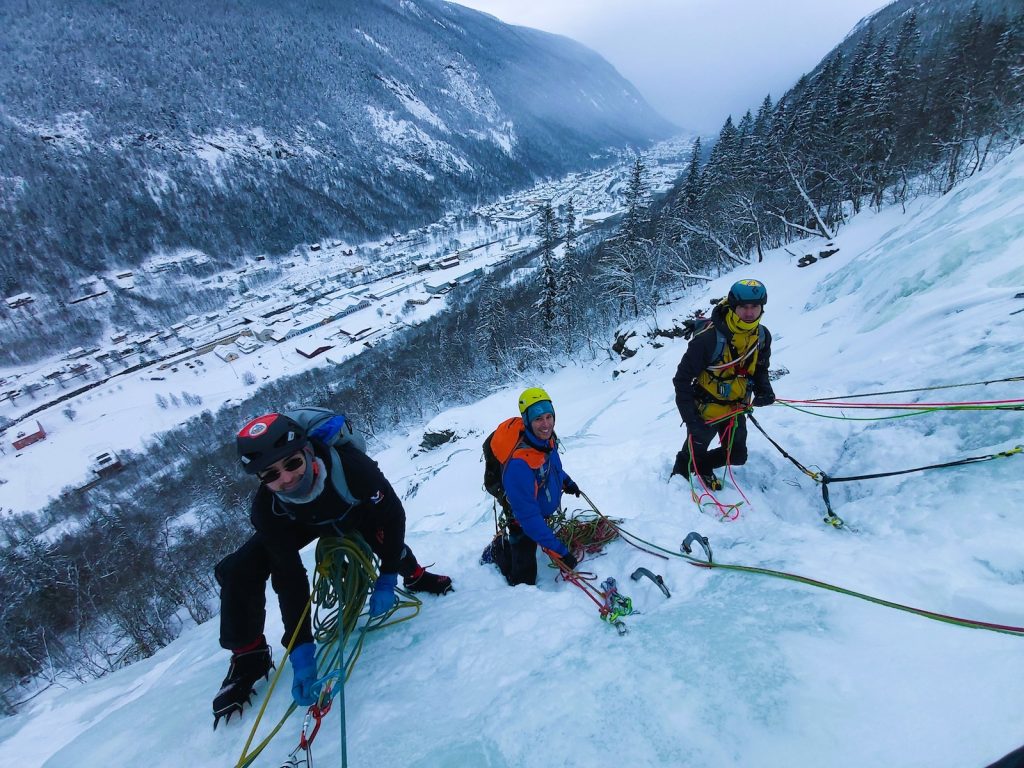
0,2,1024,720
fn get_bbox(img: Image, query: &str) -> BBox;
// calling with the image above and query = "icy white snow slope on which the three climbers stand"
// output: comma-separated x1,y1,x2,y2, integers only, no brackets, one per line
0,151,1024,768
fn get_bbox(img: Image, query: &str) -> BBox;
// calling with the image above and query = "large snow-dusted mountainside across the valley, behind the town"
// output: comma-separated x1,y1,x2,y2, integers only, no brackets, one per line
0,0,674,303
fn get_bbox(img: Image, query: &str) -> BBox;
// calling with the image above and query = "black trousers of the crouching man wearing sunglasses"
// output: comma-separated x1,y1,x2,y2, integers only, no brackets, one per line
213,525,418,650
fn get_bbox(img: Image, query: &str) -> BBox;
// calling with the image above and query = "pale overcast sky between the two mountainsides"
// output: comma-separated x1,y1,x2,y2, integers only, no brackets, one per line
459,0,891,134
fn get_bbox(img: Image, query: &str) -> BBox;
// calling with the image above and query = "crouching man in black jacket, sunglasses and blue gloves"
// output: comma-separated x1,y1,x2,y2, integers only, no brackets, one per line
213,414,452,727
